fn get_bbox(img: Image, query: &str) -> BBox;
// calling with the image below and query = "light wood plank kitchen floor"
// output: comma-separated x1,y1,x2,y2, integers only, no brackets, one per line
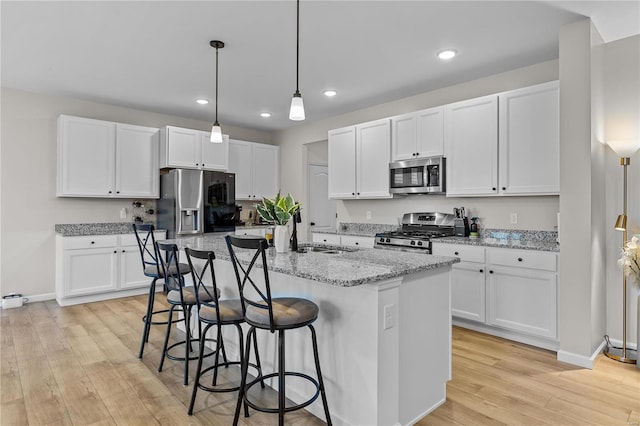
0,296,640,426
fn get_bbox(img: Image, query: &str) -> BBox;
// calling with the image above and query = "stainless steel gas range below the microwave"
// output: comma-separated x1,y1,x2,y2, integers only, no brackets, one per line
375,213,455,254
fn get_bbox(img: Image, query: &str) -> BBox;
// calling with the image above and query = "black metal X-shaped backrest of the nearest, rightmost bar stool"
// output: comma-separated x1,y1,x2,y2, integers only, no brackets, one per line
225,235,275,331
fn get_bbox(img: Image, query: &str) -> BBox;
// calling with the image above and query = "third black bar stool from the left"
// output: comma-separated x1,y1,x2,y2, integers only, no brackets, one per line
185,248,264,415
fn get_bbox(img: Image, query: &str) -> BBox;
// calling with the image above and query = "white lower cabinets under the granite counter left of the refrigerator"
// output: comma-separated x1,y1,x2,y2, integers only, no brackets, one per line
56,231,166,306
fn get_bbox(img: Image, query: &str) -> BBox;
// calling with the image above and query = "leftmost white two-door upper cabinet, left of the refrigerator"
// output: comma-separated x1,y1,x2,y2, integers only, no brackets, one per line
57,115,159,198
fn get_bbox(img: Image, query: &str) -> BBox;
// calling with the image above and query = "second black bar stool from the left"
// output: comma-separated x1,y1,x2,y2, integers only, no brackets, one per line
156,242,217,386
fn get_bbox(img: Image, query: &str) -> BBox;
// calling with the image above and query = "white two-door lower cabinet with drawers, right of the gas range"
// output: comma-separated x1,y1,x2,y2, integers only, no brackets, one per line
433,243,557,348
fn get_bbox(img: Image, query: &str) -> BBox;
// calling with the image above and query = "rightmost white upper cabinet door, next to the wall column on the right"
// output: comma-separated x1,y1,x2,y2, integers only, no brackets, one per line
498,81,560,195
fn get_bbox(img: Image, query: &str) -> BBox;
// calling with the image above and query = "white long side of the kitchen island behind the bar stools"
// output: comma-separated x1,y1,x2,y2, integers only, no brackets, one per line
210,260,390,425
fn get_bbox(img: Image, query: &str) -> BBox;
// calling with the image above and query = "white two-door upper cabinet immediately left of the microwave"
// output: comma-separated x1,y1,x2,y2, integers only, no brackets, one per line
329,119,391,199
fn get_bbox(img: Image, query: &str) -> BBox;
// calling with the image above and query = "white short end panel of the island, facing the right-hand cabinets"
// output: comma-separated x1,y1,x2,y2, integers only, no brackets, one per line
399,266,451,425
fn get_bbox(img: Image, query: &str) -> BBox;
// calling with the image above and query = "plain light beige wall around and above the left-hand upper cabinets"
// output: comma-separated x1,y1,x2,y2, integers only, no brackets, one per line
0,88,272,299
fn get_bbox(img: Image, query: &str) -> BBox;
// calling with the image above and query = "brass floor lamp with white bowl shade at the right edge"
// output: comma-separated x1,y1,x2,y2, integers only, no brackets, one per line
604,140,640,364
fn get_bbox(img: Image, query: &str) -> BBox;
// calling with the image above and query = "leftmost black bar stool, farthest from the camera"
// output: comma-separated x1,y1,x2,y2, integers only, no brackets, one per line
133,223,191,358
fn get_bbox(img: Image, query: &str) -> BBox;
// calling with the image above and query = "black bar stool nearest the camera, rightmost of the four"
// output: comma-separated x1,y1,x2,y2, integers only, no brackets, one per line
225,235,332,426
